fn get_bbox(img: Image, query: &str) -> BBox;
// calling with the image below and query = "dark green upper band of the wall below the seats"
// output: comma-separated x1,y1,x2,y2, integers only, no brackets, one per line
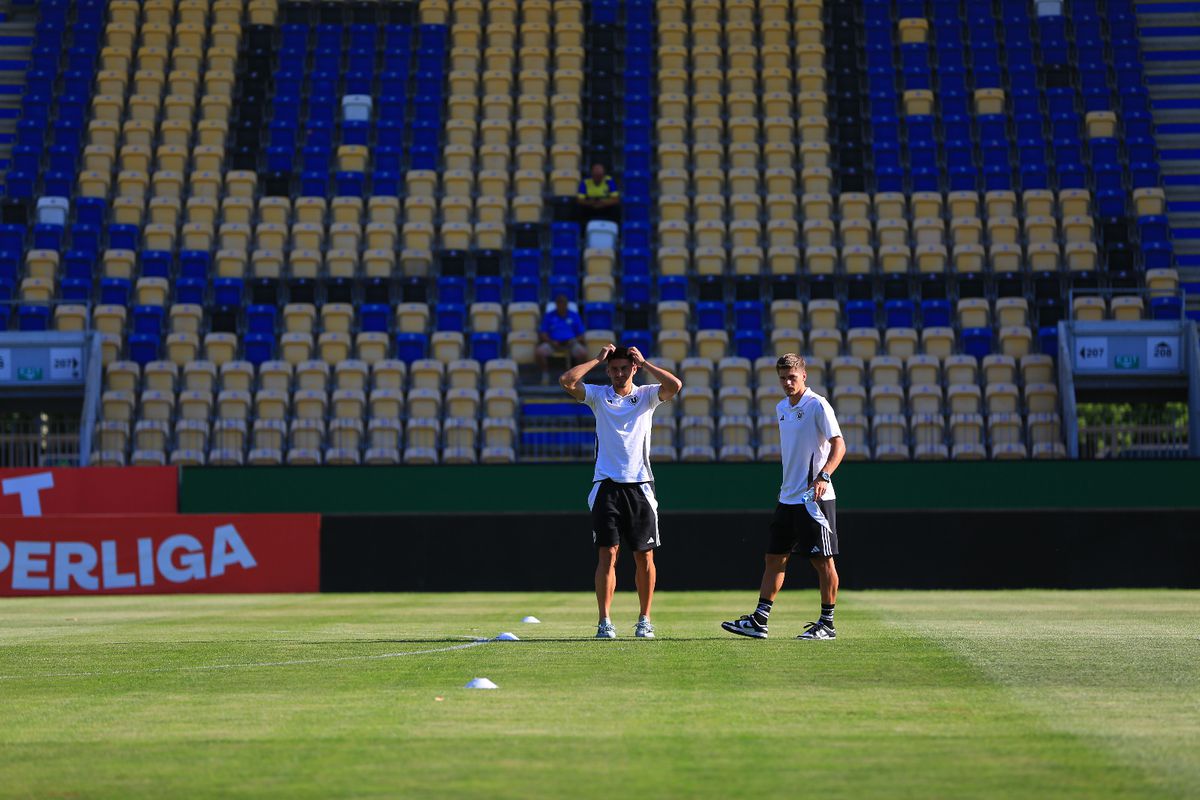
180,461,1200,513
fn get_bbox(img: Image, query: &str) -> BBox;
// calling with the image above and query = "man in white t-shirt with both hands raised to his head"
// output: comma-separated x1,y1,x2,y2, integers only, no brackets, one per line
558,344,683,639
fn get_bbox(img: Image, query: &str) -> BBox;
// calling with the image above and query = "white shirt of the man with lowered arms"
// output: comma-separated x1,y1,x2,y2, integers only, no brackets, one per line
775,389,841,505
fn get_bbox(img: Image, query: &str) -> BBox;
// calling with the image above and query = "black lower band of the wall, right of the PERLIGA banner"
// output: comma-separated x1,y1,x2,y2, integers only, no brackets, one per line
320,511,1200,597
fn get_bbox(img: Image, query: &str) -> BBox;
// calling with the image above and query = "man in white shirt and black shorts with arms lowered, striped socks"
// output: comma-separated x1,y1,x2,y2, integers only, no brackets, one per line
721,353,846,639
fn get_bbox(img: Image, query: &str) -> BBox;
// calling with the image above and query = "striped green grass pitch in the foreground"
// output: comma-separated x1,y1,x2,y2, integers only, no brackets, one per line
0,589,1200,800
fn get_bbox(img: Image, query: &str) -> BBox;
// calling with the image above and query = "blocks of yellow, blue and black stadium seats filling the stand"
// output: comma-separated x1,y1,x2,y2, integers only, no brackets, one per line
0,0,1180,464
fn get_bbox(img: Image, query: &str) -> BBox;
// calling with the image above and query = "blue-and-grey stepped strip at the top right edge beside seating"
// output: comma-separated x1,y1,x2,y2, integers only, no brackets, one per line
1134,0,1200,320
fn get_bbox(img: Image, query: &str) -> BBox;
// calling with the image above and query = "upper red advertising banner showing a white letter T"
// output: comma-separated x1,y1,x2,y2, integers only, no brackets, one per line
0,467,179,517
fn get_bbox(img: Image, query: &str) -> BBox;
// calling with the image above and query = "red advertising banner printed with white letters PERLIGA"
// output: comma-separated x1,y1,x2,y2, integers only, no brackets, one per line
0,515,320,597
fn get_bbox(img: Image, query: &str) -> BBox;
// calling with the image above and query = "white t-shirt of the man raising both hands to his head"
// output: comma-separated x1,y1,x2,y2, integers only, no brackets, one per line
583,384,662,483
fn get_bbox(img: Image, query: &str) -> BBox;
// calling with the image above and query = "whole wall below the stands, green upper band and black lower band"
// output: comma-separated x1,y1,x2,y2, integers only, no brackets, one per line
181,462,1200,591
